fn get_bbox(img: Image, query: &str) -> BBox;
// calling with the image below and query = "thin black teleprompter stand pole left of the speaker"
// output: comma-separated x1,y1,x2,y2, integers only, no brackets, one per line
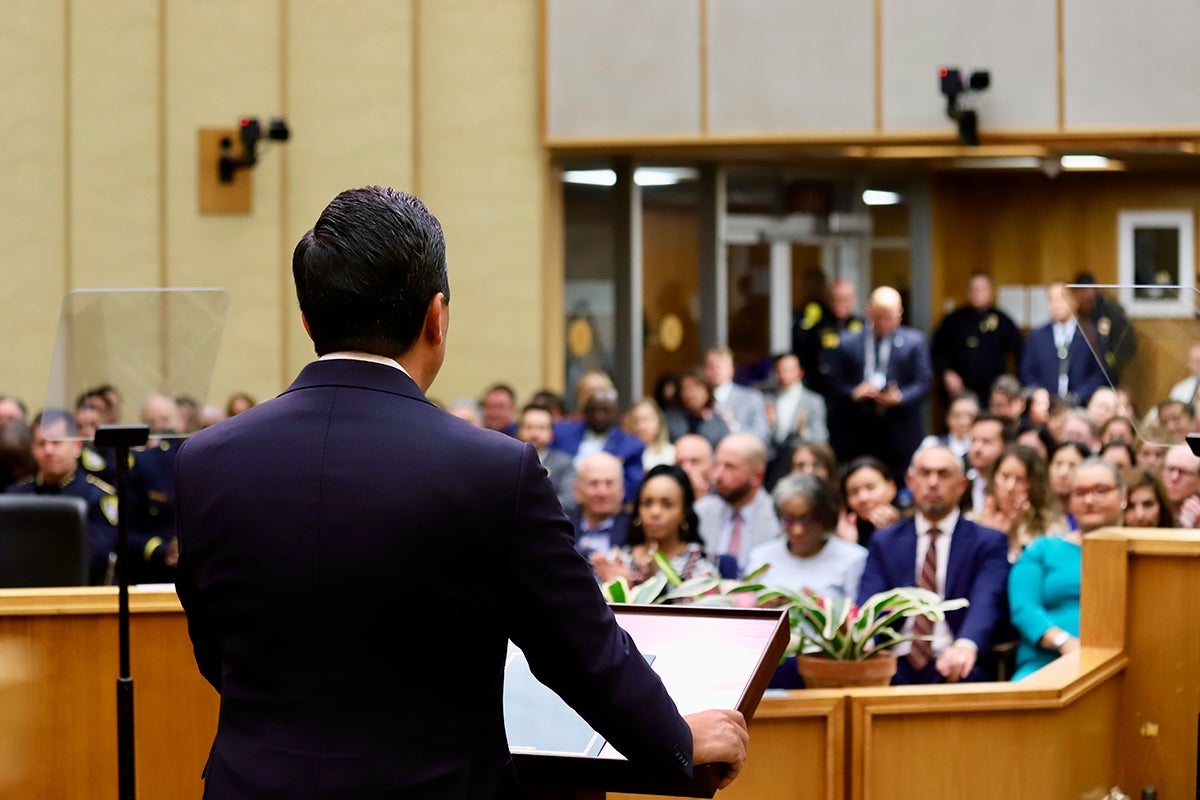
95,425,150,800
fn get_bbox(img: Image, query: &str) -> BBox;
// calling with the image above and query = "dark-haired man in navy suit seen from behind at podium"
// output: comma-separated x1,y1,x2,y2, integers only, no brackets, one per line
176,187,746,800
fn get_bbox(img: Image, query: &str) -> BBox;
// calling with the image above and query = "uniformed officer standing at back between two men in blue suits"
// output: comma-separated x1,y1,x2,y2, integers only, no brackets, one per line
930,272,1024,401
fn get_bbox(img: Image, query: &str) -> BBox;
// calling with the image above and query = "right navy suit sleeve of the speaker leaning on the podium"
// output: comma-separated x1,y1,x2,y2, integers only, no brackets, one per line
504,445,692,775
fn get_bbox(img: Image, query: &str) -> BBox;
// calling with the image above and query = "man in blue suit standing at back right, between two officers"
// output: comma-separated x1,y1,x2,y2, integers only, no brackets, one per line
1019,281,1109,405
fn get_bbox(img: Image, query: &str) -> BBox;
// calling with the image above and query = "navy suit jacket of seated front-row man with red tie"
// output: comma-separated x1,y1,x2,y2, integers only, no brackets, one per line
858,516,1009,661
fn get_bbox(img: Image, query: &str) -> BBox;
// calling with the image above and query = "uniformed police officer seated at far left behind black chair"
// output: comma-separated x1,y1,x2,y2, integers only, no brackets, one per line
8,409,116,584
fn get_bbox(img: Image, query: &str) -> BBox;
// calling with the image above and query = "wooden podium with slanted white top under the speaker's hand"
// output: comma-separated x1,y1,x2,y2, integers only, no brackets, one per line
509,606,788,800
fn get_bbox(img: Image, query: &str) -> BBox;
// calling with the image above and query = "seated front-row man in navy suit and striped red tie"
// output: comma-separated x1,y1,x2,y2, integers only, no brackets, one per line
858,445,1008,684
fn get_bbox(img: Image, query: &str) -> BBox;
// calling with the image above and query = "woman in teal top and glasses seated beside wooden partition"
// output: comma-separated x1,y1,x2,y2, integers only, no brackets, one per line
1008,458,1126,680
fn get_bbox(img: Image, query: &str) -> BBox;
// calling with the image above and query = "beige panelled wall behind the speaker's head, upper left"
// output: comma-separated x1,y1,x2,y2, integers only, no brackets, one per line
0,0,544,419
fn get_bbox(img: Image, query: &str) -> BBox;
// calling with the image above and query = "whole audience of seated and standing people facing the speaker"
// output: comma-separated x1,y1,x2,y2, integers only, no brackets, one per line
0,275,1200,682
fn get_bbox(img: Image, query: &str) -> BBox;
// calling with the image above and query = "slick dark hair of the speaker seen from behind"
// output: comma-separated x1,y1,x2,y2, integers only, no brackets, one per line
292,186,450,356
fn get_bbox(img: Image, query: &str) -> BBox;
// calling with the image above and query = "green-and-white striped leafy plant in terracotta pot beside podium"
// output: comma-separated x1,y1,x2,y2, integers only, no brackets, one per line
758,587,968,688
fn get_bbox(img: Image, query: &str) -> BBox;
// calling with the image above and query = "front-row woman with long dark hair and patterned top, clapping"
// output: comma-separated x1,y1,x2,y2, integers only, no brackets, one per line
590,464,716,587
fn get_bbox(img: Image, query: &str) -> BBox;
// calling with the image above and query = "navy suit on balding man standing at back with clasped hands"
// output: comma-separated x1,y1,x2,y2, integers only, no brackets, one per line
826,326,932,482
